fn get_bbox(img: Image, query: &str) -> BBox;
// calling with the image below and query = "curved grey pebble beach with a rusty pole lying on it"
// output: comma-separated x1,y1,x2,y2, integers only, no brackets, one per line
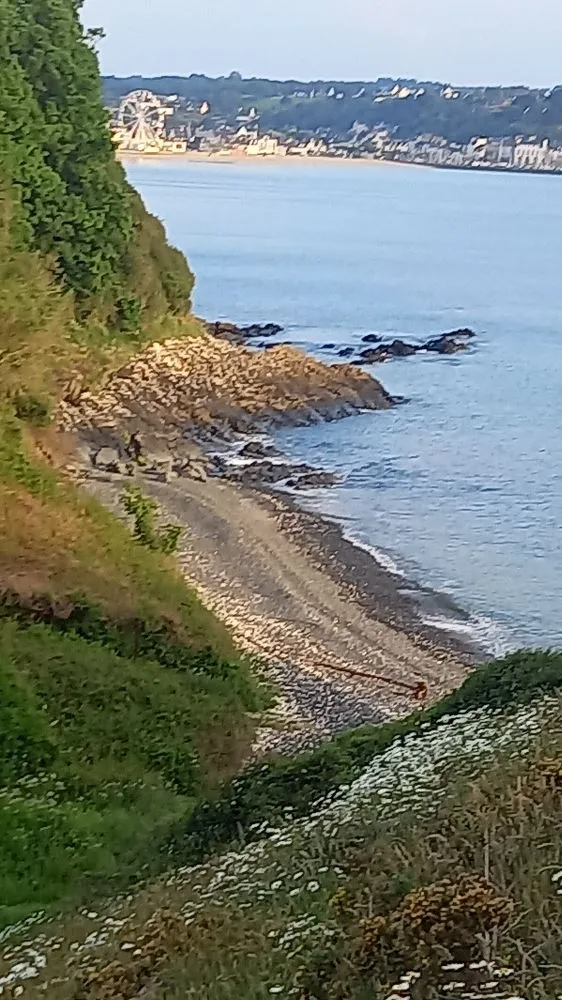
84,464,468,756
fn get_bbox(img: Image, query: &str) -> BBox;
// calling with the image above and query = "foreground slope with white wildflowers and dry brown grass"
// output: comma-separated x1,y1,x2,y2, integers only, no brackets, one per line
0,656,562,1000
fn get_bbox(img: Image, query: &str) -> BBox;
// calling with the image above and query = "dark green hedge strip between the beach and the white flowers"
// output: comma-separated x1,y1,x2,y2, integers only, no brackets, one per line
163,650,562,863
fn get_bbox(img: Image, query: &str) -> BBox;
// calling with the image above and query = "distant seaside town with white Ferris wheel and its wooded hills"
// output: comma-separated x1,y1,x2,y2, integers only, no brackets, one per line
106,74,562,173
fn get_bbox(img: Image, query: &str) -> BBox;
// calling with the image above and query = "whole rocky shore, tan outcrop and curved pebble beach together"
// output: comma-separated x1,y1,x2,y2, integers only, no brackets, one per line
59,324,486,752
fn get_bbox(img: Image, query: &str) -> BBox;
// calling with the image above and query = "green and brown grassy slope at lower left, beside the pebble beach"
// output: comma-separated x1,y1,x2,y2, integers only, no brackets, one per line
0,417,263,923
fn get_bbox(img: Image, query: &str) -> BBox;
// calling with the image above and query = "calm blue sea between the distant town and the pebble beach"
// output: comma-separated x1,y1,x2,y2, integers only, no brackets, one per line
128,161,562,651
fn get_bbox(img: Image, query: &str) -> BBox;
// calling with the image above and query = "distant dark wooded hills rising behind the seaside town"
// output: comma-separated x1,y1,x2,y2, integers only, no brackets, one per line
103,73,562,143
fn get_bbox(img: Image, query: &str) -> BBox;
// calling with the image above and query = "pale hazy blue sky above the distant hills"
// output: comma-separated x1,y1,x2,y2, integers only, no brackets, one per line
84,0,562,86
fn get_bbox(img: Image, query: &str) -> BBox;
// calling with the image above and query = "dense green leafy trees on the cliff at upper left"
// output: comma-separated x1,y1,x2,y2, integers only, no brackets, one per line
0,0,193,320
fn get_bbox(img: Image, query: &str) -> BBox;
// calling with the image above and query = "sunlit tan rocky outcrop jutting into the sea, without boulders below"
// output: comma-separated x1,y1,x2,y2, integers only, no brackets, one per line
59,335,395,454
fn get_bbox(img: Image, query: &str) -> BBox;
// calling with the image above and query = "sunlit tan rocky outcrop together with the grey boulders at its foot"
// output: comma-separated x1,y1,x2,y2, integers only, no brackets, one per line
59,331,395,488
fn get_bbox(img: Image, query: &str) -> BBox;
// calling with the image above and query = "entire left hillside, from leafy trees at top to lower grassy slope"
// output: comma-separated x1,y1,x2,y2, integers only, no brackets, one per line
0,0,262,924
